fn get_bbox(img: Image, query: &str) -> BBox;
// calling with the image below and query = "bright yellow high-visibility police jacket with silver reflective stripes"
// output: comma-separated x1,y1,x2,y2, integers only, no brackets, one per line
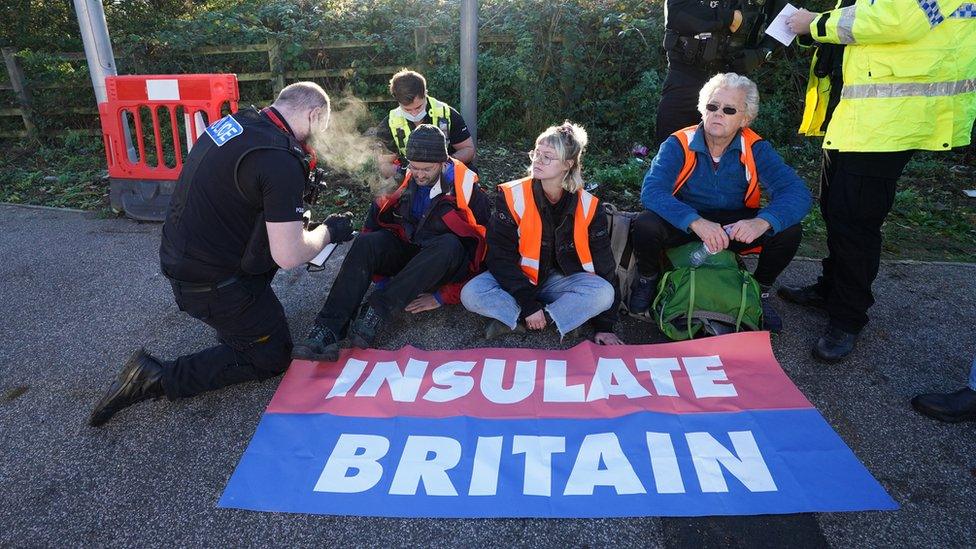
799,0,976,152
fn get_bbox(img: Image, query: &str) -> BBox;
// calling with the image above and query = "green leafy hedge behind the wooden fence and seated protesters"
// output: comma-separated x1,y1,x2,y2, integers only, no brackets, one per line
0,0,832,154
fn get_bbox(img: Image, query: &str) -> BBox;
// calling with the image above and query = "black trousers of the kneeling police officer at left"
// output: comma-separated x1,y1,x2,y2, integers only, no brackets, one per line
162,271,292,400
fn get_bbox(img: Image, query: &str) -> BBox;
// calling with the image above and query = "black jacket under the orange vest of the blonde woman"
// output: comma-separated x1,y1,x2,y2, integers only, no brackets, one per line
487,180,620,332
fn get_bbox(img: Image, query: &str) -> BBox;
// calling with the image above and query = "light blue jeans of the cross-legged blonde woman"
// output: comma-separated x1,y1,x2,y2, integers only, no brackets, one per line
461,272,613,336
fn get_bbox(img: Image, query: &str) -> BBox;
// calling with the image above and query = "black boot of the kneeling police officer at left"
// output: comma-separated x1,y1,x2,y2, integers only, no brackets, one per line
88,349,163,427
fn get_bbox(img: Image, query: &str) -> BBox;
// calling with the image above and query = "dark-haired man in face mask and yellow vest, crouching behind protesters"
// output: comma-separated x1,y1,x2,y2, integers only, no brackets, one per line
377,69,477,179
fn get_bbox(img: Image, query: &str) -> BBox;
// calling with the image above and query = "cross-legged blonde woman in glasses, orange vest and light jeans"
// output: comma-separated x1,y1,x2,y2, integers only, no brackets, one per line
461,121,623,345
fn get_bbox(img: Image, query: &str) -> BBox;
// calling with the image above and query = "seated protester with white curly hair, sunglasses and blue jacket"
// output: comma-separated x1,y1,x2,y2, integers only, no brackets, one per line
628,73,811,332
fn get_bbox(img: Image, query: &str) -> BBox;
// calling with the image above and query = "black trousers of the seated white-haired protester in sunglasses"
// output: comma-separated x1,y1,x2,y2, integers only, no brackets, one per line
631,208,803,286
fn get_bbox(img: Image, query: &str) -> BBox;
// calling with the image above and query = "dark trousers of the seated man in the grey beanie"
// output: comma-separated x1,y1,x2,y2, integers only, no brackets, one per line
315,230,467,335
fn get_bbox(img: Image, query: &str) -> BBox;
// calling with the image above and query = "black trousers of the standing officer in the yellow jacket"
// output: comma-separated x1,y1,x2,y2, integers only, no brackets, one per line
816,150,913,333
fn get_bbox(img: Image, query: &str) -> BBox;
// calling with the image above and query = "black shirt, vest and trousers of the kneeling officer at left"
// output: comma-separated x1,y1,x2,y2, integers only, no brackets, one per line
159,109,308,400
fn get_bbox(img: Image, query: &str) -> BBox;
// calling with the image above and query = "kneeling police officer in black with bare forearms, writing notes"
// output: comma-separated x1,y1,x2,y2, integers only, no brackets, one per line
89,82,352,426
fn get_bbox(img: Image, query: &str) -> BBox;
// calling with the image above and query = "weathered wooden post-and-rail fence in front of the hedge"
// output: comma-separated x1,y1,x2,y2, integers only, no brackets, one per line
0,27,562,138
